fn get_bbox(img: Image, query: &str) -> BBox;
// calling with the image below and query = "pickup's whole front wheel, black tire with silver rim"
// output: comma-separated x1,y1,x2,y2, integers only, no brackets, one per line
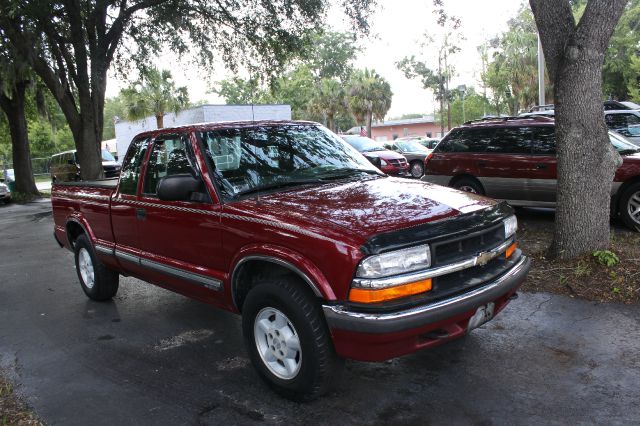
242,276,342,401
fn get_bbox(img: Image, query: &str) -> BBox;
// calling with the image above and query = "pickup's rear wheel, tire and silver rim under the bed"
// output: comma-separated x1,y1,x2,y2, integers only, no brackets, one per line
73,234,120,302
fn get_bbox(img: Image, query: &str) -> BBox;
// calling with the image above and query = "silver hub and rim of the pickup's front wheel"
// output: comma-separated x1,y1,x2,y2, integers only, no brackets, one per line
253,308,302,380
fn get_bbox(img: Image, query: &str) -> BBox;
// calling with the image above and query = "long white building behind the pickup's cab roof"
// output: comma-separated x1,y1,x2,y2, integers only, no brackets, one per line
115,105,291,161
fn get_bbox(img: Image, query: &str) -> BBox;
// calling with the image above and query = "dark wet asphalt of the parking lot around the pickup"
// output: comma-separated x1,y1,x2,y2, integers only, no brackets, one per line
0,201,640,425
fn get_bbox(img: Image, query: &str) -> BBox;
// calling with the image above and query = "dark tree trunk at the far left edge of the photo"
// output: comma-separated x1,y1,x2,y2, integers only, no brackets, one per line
0,81,39,195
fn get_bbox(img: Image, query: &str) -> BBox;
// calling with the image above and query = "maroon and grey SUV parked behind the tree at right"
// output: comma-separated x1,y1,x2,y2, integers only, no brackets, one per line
422,117,640,231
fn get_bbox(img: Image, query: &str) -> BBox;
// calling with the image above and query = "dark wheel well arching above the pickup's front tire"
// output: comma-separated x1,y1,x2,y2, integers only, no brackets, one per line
231,259,316,311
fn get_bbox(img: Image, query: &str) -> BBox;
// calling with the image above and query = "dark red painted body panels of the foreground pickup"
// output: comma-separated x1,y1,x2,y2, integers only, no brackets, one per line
51,123,524,360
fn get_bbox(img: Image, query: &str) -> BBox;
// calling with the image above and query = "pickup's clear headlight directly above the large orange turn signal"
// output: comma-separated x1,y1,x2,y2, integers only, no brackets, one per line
356,244,431,278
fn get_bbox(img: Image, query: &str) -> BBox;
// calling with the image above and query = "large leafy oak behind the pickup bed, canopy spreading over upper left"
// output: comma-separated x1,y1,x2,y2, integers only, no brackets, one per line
0,0,373,179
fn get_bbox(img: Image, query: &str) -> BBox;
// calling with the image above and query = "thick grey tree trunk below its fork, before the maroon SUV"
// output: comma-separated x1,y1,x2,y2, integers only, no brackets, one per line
551,45,622,258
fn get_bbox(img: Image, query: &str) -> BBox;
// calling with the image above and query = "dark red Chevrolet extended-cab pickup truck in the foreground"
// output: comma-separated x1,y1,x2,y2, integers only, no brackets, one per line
51,122,529,400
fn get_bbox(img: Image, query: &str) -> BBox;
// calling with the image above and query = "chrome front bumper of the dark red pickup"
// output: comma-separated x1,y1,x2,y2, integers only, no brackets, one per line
322,255,531,334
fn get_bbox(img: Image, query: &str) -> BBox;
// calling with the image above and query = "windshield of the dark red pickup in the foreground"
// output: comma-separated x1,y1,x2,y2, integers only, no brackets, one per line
200,124,383,198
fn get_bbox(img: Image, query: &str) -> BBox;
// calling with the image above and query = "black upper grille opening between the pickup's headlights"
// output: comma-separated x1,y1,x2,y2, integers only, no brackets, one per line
431,222,504,266
